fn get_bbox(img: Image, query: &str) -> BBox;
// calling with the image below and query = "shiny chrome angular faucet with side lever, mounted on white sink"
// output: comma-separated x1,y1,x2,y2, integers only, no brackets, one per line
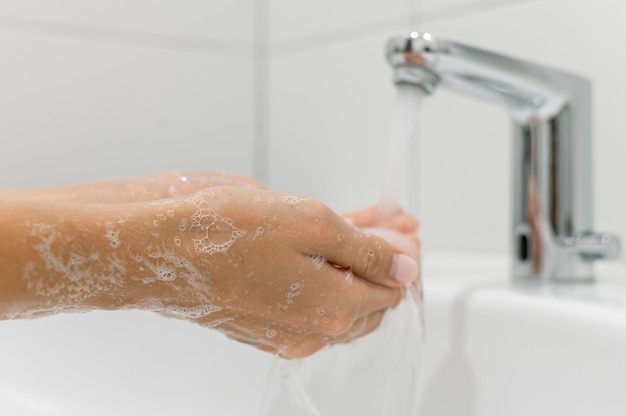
387,32,620,281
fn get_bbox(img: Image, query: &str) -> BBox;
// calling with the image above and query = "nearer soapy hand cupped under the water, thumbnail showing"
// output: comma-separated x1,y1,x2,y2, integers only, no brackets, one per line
134,187,417,357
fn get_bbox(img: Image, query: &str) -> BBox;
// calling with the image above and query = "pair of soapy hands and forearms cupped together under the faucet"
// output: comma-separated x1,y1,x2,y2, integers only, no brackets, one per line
0,172,418,358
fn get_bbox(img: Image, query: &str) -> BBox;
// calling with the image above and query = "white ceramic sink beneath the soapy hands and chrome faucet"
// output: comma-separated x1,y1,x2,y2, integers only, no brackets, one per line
0,255,626,416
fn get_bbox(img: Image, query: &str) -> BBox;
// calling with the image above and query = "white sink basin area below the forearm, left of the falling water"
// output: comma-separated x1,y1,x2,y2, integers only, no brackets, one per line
0,312,272,416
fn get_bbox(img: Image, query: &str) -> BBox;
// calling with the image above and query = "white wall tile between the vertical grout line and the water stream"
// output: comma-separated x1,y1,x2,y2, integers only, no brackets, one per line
269,30,393,210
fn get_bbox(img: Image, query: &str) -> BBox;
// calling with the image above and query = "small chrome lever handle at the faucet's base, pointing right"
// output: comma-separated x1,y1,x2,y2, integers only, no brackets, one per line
557,231,621,261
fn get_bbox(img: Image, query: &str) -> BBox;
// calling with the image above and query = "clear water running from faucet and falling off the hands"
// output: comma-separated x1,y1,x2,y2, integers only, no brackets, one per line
261,85,424,416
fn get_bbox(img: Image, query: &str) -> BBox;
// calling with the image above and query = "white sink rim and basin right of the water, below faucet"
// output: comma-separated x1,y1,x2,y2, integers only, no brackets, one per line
419,255,626,416
